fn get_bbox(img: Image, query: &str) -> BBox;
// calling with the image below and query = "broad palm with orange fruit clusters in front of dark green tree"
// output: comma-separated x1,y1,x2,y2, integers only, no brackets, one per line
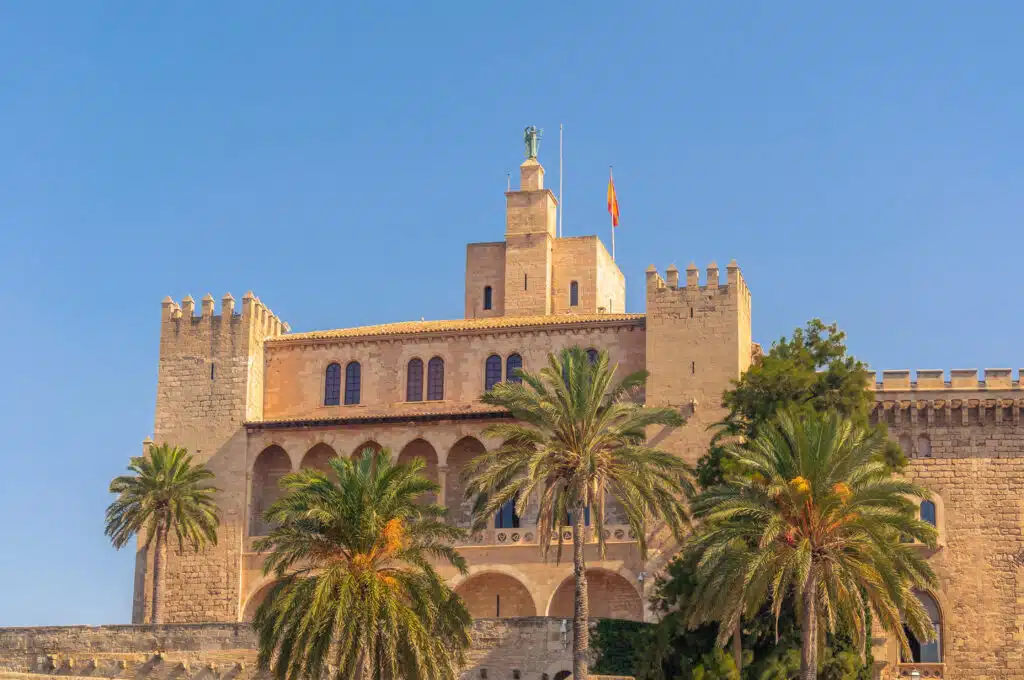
692,413,936,680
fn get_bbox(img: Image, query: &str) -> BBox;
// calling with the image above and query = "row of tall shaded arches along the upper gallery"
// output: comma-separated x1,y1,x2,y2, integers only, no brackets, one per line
249,436,499,536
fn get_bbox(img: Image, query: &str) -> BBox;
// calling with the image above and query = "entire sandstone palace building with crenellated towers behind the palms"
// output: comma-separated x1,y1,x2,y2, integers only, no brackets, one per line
0,148,1024,680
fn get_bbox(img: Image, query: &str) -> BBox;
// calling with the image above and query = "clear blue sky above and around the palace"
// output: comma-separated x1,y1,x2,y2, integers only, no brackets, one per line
0,0,1024,626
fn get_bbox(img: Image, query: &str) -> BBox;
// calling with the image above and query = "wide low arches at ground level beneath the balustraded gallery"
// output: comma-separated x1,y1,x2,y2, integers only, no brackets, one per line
243,568,643,621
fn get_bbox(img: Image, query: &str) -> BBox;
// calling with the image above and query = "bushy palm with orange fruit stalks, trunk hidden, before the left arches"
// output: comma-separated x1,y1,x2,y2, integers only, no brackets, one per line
253,449,470,680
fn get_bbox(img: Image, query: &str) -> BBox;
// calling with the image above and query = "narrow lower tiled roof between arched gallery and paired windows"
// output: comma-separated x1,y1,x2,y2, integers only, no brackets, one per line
246,401,508,428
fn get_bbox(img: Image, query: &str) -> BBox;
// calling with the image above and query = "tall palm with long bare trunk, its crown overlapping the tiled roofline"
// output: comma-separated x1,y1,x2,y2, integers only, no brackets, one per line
467,347,692,680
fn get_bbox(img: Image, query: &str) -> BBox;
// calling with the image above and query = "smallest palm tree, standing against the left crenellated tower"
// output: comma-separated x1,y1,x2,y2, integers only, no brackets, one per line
105,443,220,624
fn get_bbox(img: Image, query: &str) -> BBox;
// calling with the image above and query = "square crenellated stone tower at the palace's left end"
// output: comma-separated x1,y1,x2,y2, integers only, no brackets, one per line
132,293,287,623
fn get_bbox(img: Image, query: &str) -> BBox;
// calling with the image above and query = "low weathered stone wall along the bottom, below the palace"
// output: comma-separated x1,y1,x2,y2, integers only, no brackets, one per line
0,617,606,680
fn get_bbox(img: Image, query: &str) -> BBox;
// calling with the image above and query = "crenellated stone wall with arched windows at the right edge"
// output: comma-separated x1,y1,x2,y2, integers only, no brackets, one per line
876,383,1024,680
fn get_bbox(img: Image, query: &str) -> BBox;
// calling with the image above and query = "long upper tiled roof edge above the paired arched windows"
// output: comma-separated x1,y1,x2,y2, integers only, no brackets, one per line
266,314,644,344
